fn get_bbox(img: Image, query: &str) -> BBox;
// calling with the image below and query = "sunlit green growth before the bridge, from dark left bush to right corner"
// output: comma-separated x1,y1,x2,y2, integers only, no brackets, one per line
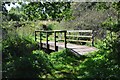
50,47,120,79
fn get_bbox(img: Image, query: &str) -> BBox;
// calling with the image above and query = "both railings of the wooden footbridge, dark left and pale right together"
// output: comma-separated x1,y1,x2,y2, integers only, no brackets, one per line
35,30,94,51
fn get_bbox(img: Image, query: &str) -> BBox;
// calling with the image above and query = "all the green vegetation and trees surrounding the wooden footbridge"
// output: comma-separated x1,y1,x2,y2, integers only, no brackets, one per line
0,2,120,80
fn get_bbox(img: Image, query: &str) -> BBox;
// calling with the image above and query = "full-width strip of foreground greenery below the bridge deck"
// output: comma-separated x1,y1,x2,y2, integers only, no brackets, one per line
3,39,120,80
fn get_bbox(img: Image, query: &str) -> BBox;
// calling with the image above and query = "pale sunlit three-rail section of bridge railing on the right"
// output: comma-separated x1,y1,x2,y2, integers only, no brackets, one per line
66,30,94,46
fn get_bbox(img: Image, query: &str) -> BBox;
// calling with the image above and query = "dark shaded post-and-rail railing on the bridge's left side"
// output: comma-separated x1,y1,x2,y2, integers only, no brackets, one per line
35,30,67,51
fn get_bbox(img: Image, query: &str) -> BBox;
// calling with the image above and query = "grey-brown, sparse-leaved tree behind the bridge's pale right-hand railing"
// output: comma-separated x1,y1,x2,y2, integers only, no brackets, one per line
61,2,117,29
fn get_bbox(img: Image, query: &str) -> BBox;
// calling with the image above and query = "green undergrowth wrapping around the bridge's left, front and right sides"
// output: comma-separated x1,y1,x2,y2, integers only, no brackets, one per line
2,21,120,80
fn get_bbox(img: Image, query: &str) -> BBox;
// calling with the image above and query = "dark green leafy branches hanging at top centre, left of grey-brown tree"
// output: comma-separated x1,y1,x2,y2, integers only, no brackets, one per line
24,2,71,22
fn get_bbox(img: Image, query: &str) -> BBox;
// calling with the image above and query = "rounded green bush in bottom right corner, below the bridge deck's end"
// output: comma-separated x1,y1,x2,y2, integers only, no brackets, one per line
78,50,120,80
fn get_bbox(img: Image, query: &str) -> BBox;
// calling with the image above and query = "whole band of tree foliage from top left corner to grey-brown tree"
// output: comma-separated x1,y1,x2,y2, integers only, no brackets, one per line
2,2,72,22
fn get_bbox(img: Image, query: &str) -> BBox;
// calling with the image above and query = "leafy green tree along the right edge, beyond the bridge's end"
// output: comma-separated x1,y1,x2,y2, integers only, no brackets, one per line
96,2,120,66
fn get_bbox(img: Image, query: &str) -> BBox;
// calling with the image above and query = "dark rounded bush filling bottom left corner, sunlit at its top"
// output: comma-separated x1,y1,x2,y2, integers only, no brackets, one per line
3,50,51,78
